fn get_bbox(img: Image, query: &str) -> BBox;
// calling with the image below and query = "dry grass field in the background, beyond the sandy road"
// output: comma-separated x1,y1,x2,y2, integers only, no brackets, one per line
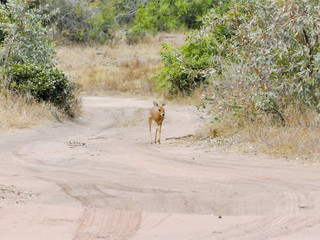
57,33,184,95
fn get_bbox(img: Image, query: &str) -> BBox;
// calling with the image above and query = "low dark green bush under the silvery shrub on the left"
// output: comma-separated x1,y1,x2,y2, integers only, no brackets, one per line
9,64,77,116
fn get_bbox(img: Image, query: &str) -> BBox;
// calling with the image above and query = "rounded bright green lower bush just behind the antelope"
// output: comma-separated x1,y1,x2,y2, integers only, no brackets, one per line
154,39,216,95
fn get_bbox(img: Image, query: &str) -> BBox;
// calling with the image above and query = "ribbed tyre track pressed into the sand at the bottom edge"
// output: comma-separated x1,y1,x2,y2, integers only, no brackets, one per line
59,183,141,240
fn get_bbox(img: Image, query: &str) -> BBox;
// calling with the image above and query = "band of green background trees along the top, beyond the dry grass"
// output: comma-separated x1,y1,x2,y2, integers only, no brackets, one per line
34,0,222,43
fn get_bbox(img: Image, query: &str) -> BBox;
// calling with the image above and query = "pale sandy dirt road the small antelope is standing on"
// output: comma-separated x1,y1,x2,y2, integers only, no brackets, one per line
0,97,320,240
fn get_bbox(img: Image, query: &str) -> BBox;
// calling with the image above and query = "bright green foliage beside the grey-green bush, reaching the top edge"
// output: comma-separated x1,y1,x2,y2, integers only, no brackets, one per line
154,2,233,94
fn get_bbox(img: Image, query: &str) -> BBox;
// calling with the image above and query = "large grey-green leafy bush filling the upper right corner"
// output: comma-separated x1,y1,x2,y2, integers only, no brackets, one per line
211,0,320,124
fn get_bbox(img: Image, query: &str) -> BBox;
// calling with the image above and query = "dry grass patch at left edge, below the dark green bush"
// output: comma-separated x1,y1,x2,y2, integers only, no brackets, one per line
0,93,54,132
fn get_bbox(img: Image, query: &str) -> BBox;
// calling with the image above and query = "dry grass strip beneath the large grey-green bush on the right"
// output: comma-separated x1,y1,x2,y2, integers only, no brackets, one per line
202,108,320,162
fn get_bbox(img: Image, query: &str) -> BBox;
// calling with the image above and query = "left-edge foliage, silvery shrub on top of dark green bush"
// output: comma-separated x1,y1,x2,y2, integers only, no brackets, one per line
0,0,76,116
